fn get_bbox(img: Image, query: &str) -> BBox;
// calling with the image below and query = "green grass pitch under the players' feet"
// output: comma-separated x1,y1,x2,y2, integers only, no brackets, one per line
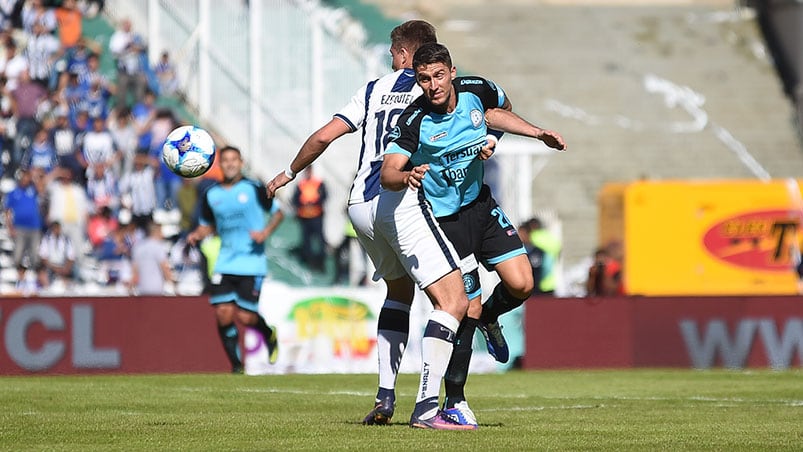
0,369,803,451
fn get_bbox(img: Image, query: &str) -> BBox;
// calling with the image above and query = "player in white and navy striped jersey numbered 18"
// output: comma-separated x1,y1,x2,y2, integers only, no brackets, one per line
268,20,476,430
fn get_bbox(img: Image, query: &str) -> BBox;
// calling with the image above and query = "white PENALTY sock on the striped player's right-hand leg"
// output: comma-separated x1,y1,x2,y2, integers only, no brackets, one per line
415,310,460,419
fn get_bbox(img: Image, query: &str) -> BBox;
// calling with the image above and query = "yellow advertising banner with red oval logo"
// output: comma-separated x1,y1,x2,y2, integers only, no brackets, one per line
624,180,803,295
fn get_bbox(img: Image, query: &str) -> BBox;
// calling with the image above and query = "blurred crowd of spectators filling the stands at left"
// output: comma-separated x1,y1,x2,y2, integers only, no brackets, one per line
0,0,209,295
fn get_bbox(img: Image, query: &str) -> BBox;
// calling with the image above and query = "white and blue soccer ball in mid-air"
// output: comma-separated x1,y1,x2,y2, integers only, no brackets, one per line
162,126,215,177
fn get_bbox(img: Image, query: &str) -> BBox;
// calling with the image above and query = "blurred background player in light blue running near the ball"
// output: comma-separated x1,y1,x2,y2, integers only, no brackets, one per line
187,146,284,373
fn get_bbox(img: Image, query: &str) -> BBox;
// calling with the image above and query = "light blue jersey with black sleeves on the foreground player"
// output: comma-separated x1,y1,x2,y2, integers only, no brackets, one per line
385,77,505,217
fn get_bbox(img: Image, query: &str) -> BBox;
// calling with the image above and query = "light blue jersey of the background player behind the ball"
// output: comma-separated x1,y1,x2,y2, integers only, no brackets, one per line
200,179,279,276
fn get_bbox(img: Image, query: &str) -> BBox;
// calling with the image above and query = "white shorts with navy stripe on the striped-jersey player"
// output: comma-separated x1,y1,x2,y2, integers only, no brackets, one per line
348,189,470,289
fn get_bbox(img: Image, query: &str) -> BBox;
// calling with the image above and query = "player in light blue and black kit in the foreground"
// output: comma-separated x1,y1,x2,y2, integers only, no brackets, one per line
380,43,566,424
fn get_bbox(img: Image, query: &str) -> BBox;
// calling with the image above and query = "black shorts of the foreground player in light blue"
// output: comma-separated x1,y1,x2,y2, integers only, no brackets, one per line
438,185,527,270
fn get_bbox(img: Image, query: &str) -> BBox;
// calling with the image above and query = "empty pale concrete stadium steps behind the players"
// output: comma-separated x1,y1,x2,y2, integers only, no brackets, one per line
348,0,803,267
